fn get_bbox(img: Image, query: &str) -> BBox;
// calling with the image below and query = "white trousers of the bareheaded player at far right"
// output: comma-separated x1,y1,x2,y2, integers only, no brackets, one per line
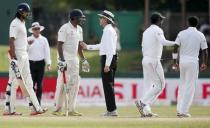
177,62,199,114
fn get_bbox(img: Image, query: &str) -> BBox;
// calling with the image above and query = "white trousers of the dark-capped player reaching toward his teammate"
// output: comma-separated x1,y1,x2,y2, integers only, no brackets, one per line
141,57,165,106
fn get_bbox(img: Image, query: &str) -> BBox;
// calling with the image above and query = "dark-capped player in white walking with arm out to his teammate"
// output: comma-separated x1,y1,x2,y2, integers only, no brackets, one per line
135,12,175,117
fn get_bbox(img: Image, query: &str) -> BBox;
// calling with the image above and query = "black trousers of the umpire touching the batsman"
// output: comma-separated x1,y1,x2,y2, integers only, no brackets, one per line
101,55,117,112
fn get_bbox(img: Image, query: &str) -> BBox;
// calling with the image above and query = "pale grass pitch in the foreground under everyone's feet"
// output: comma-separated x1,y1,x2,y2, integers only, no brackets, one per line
0,106,210,128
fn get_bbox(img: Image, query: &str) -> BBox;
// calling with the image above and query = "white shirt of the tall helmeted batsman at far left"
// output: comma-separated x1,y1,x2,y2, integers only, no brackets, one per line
9,18,28,53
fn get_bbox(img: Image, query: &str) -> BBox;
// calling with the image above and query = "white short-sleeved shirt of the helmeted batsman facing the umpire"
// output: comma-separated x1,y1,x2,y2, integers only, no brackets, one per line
58,22,83,60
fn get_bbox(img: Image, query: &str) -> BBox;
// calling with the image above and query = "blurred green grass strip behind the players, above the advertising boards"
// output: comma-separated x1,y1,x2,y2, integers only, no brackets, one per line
0,45,141,77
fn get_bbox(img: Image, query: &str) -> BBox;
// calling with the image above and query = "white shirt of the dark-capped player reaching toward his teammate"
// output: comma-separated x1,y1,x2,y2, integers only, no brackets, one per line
142,25,175,59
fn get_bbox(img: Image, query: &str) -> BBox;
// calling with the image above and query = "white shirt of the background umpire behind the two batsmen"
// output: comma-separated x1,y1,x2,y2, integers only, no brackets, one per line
28,34,51,65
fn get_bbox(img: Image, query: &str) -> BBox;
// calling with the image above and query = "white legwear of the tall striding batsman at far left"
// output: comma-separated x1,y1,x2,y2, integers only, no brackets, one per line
5,51,42,112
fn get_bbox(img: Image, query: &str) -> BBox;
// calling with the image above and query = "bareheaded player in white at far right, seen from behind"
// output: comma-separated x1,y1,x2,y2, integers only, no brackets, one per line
172,16,208,118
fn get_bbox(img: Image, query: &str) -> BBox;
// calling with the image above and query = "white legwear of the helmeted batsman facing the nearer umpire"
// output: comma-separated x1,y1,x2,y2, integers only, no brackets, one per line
55,57,80,111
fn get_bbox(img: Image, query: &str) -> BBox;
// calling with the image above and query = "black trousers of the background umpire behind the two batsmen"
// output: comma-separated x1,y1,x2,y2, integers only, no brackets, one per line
29,60,45,104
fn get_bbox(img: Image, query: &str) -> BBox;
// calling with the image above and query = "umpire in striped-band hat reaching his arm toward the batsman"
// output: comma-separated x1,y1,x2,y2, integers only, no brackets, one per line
81,10,118,116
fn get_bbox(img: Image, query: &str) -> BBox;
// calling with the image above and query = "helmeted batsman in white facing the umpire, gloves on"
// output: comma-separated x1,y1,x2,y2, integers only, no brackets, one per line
53,9,89,116
